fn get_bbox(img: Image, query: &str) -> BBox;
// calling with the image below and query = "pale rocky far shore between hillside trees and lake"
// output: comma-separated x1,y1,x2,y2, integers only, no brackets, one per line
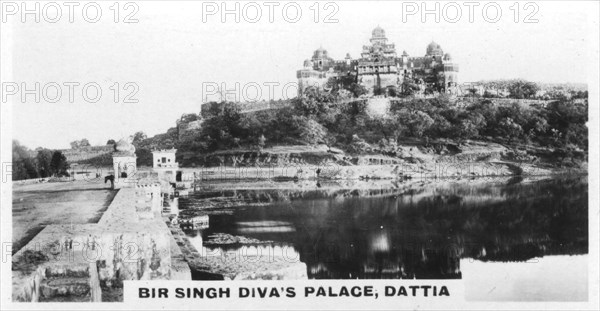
175,142,586,181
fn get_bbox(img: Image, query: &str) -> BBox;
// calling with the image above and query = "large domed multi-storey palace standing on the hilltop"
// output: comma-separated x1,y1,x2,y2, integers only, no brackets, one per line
297,26,458,95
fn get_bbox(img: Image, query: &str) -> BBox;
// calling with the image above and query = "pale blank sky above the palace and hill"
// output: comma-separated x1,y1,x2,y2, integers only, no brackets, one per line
1,1,598,148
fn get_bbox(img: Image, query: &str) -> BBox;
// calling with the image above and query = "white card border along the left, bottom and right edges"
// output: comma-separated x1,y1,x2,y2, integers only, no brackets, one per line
0,1,600,310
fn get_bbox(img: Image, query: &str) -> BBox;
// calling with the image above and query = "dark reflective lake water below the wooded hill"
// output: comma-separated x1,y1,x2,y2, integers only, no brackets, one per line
179,177,588,301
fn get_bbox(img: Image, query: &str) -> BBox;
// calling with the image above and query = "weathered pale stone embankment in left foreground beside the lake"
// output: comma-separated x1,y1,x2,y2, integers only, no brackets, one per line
13,183,191,302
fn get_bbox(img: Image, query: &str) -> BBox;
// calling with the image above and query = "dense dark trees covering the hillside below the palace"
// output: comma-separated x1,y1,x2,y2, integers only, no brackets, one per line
63,79,588,166
